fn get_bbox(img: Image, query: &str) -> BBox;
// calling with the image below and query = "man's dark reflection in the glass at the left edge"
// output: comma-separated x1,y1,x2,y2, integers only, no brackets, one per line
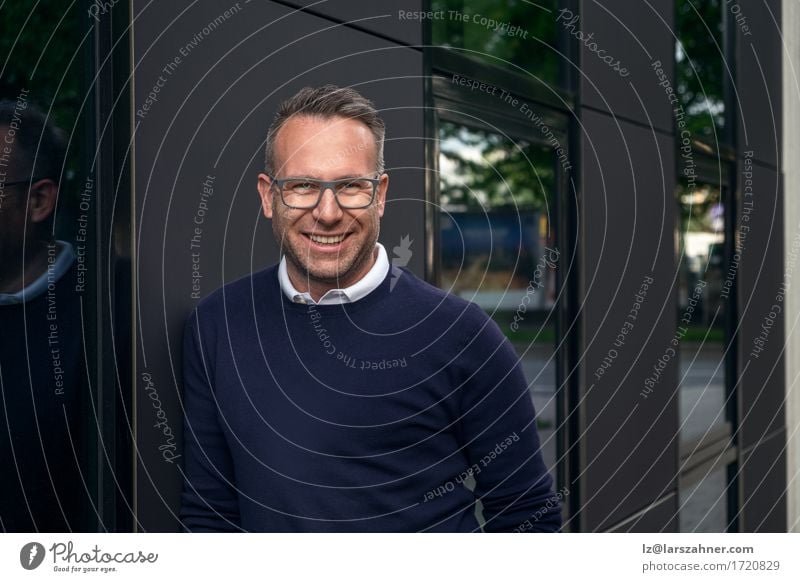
0,99,83,531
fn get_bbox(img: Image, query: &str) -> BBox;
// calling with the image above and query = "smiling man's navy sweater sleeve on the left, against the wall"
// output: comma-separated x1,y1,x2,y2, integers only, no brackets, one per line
180,310,241,531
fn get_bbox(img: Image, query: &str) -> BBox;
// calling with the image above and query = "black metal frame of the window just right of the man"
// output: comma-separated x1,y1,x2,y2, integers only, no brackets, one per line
423,24,581,530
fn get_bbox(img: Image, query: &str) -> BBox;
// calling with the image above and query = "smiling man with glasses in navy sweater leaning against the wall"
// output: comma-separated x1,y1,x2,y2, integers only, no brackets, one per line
181,86,560,532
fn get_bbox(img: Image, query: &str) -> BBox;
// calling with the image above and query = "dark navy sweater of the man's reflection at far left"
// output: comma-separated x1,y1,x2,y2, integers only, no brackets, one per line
0,264,88,532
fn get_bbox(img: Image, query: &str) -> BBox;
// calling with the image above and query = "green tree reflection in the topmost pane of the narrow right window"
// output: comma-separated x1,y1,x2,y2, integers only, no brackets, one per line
675,0,726,139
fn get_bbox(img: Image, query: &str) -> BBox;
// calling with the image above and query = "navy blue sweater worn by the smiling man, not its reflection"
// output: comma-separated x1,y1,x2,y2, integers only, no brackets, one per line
181,266,561,532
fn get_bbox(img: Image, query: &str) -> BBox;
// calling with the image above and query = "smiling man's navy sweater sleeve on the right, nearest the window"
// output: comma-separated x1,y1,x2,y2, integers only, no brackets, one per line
458,305,561,532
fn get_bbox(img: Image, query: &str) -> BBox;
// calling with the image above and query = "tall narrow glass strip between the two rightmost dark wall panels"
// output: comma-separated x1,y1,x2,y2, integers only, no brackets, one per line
675,0,739,531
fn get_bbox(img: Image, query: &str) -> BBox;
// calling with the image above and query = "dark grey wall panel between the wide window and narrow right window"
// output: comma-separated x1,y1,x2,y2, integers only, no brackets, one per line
577,0,678,531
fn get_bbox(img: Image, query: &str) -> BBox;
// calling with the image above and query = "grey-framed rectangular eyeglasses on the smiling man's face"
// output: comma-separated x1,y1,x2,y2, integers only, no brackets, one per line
269,176,380,210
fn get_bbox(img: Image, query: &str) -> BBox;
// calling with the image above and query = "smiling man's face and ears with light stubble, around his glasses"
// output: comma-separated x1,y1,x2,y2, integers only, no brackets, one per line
258,116,389,288
